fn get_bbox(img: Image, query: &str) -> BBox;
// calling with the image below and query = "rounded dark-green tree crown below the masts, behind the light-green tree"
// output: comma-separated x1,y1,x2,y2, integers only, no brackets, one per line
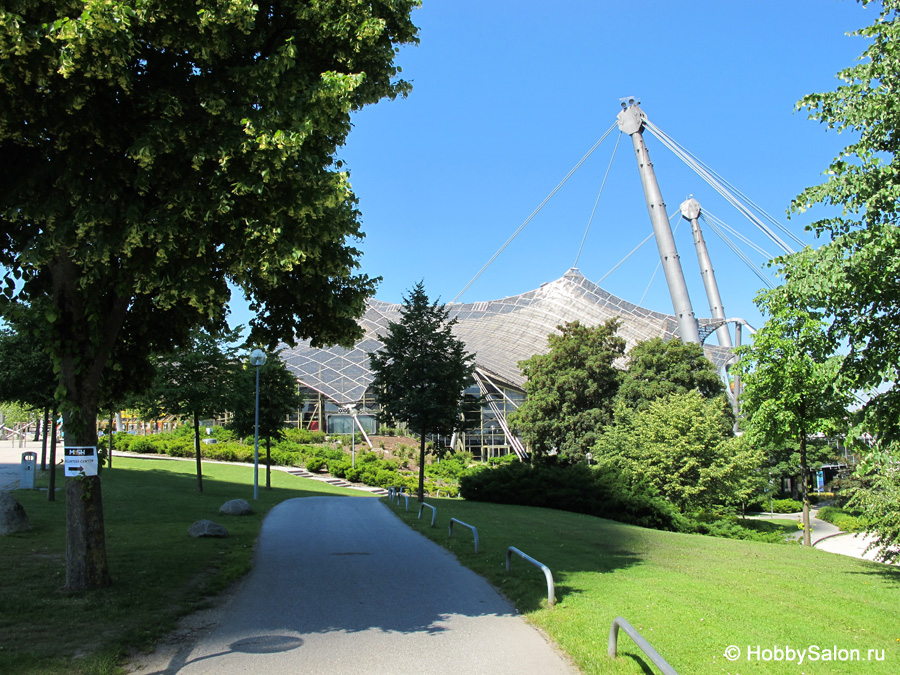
618,338,725,410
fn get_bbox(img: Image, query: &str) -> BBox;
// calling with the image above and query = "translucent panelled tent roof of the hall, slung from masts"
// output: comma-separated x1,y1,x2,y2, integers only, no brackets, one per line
281,269,730,405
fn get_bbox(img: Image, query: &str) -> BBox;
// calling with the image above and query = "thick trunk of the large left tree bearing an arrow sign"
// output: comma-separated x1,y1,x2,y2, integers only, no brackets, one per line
63,403,112,591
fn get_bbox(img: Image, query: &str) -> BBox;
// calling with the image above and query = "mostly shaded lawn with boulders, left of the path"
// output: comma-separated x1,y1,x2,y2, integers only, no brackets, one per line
0,457,364,675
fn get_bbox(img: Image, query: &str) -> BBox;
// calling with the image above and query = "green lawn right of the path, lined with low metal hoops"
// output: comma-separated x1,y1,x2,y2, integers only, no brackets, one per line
384,499,900,675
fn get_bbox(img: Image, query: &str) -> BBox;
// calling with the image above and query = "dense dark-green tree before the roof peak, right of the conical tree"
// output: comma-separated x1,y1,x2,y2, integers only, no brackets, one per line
509,319,625,460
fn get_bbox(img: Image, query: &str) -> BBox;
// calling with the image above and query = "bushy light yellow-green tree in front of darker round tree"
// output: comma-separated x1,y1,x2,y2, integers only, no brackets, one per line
595,389,762,513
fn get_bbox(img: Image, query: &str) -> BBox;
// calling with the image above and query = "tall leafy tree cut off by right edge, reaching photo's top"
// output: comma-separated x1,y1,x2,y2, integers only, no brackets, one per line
778,0,900,440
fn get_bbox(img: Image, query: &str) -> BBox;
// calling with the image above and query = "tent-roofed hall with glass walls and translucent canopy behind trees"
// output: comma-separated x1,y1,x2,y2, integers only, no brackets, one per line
281,269,731,459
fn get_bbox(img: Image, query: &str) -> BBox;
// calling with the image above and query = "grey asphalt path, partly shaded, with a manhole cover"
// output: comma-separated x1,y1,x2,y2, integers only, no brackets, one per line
126,497,578,675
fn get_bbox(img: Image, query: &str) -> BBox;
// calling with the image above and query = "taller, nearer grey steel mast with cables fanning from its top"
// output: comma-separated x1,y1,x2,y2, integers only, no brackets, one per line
617,99,700,344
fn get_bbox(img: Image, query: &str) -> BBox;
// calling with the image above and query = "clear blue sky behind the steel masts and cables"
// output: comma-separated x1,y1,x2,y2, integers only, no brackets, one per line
235,0,878,336
